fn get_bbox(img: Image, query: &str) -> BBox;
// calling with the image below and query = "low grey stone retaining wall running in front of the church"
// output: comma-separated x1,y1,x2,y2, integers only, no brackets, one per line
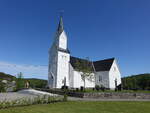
36,89,150,99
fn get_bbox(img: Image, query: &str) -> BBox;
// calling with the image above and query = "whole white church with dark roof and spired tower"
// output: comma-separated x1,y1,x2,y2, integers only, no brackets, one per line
48,17,121,89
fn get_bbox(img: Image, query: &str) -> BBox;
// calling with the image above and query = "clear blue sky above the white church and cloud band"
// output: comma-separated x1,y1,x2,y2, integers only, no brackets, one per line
0,0,150,78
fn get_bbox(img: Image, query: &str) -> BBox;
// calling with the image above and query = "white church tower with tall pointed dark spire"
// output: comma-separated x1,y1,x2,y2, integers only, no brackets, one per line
48,17,70,88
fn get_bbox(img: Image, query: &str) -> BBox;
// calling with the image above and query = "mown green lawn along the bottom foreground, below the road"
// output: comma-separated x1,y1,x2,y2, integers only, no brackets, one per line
0,101,150,113
